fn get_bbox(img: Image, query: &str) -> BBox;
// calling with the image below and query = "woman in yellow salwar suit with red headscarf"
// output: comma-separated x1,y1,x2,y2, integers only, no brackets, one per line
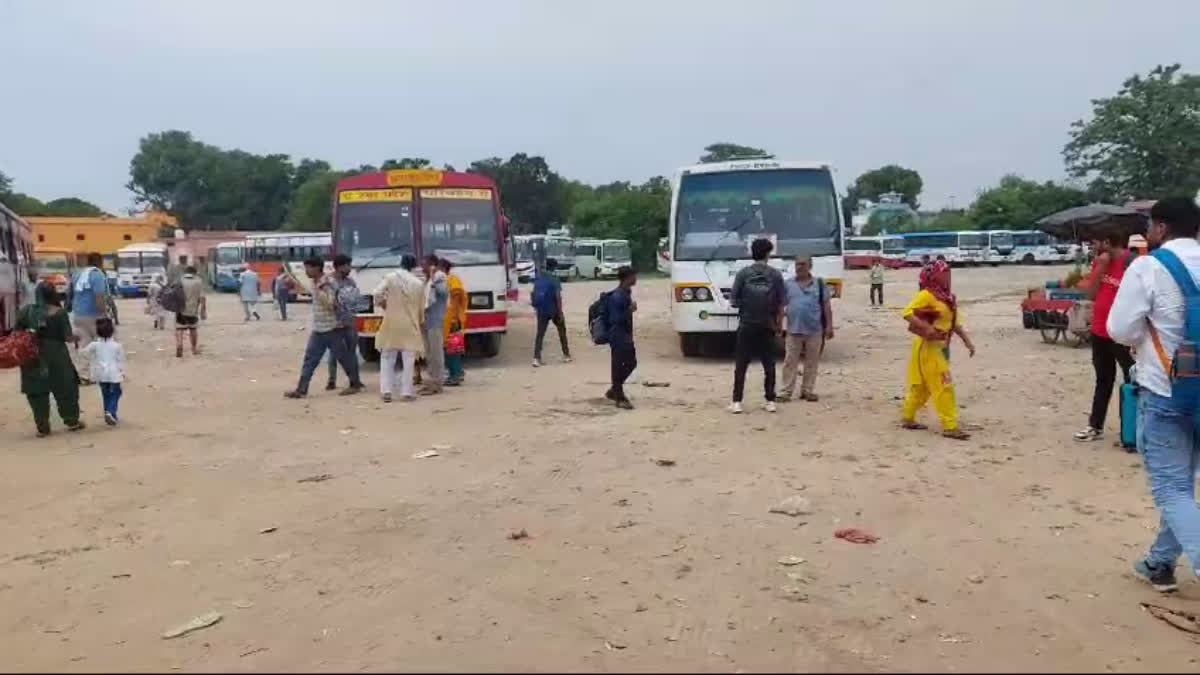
902,261,974,441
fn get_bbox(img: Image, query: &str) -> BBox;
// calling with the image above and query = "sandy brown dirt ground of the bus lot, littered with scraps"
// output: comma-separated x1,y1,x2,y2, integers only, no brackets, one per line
0,268,1200,673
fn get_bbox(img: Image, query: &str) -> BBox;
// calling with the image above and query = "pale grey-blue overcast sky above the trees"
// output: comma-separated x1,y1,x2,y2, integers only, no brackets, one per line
0,0,1200,213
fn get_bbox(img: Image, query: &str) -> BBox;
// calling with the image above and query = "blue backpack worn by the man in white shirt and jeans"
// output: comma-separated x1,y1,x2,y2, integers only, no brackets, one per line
1150,249,1200,415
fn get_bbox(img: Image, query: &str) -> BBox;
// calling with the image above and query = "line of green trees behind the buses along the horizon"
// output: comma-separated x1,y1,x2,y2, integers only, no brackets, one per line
0,64,1200,263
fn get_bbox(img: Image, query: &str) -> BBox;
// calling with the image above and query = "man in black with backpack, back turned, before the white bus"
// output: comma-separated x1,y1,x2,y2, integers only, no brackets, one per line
730,239,787,414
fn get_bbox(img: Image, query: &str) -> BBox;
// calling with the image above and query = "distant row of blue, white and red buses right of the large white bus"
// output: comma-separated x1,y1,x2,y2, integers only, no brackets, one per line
845,229,1081,269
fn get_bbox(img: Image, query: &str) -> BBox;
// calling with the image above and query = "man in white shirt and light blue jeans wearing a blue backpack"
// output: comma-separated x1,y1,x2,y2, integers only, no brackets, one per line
1108,197,1200,592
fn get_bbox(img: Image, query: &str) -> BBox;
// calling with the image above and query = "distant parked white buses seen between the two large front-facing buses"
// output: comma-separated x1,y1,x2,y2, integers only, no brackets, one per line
512,234,632,283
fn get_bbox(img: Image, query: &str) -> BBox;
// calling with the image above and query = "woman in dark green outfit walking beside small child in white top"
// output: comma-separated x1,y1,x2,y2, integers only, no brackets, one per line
17,283,84,437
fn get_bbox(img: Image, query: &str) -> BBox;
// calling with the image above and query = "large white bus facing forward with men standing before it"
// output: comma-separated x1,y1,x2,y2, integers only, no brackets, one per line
668,160,844,357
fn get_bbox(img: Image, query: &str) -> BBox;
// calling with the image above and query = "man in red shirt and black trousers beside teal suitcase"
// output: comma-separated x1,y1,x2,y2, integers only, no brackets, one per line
1075,233,1133,442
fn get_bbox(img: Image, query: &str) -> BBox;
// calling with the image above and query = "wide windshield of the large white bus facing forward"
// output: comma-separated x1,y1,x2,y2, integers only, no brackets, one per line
674,169,841,261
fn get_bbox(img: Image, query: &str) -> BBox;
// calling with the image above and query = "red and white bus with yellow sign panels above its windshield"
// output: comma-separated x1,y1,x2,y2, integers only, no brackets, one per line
334,169,512,360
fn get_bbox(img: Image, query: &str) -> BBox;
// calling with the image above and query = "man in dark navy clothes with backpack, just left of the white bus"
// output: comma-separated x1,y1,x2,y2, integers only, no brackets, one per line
588,265,637,410
